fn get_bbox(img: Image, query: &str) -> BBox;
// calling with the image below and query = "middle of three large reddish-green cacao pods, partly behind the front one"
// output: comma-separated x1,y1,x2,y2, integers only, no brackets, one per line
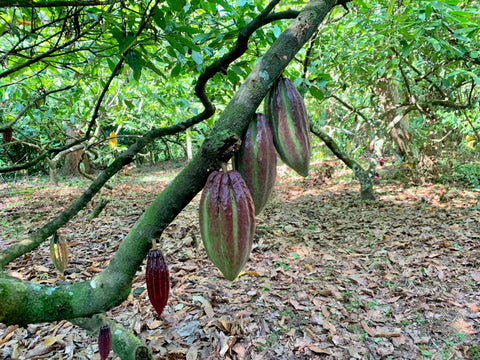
235,113,277,215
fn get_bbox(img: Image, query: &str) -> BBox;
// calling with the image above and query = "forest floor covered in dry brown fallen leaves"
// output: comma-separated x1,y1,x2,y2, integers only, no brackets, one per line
0,164,480,360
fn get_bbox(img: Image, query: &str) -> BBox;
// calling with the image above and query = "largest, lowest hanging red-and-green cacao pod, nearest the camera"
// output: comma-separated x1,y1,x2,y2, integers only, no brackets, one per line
200,170,255,281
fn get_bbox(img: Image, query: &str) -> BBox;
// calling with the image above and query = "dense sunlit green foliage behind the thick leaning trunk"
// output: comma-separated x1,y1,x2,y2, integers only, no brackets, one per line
0,0,480,186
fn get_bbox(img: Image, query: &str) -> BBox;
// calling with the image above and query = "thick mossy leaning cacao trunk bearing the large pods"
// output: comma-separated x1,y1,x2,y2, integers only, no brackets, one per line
0,0,336,326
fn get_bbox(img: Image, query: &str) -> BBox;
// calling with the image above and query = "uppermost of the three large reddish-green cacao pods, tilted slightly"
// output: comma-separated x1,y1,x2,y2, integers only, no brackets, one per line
265,76,312,176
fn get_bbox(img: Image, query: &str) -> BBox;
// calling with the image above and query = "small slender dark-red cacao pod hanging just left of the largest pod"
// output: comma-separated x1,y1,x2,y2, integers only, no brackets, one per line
145,249,170,316
